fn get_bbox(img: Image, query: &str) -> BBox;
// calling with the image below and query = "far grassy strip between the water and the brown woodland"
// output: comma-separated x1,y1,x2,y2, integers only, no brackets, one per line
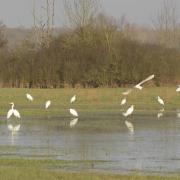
0,87,180,117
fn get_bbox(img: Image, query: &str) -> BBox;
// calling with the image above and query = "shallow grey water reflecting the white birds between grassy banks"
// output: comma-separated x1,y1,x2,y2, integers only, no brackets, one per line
0,113,180,174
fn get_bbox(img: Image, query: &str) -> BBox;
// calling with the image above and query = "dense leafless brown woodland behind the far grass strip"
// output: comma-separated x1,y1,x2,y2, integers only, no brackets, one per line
0,0,180,88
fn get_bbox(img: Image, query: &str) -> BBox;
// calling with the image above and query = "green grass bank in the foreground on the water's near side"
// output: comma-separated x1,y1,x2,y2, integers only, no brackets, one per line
0,159,180,180
